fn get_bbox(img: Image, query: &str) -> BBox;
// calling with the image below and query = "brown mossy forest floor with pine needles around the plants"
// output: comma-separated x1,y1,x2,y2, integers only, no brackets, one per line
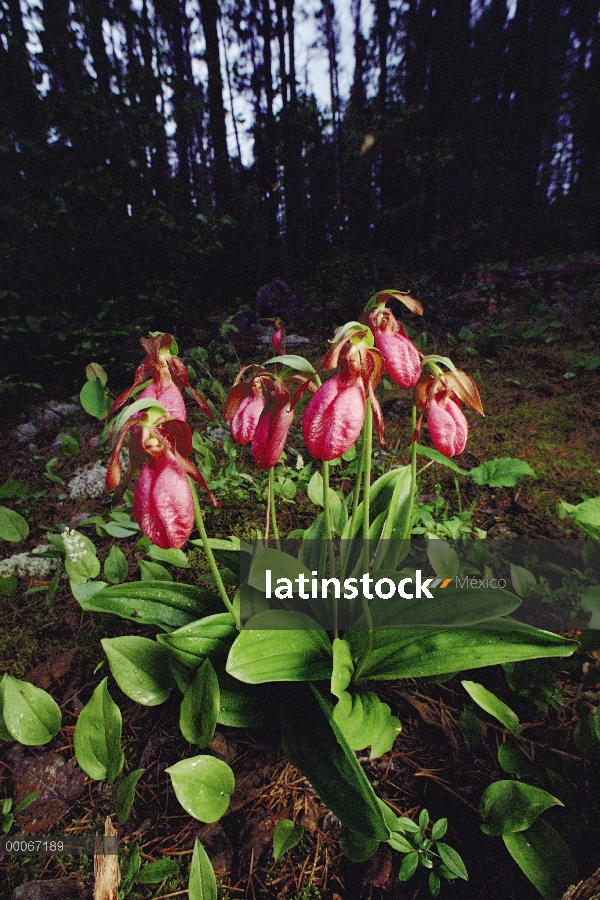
0,256,600,900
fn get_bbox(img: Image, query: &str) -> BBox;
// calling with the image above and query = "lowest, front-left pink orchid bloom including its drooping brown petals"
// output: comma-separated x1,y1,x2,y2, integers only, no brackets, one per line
106,409,219,550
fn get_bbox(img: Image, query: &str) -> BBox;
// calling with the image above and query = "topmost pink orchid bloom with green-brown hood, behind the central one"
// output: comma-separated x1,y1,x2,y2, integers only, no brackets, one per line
367,291,423,388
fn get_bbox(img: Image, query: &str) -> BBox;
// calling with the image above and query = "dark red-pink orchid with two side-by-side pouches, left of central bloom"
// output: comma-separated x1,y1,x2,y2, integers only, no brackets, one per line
224,365,314,469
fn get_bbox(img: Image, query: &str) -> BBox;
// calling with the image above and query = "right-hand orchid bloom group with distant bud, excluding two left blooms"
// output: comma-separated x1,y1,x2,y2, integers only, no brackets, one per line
225,291,483,470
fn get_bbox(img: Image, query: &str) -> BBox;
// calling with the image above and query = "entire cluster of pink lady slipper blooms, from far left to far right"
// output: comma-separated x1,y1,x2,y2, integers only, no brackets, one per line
106,291,483,549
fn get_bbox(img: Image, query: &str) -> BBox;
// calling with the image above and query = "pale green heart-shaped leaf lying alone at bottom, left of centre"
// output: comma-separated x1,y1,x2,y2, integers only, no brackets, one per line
165,756,235,822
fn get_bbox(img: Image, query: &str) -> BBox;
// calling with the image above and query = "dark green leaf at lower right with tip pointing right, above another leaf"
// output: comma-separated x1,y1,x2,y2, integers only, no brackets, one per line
479,781,564,835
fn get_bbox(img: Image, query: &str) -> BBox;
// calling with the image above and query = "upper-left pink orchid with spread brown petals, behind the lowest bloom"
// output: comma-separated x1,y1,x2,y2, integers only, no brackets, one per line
109,334,215,422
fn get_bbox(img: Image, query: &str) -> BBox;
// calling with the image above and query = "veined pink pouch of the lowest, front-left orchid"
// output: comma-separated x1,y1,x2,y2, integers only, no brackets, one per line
133,453,194,550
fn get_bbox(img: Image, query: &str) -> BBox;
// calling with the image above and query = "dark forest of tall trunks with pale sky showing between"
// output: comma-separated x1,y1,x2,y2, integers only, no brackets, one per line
0,0,600,394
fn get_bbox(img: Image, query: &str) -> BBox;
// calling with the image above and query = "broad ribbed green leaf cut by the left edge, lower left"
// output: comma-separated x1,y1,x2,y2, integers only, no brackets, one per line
4,675,62,747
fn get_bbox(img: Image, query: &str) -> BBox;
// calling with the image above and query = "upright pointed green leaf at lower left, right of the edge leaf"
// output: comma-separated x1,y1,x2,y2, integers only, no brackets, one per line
73,678,124,784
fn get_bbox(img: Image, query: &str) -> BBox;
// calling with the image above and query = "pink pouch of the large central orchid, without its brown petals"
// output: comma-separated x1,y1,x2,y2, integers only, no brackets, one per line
302,375,365,460
